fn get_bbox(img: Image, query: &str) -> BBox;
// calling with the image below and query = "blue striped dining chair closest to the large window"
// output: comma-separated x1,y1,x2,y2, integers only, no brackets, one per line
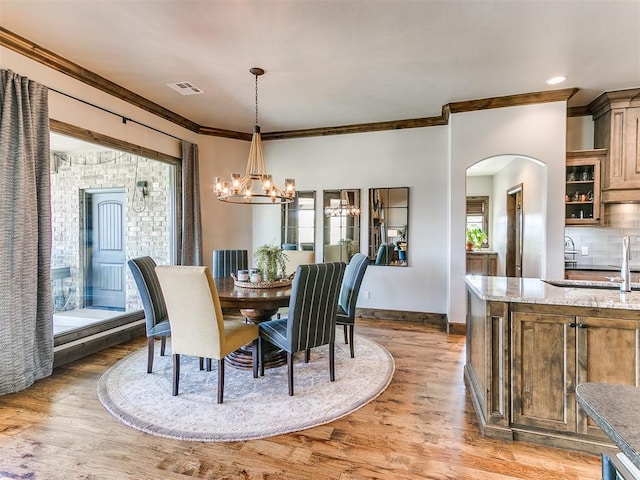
127,257,171,373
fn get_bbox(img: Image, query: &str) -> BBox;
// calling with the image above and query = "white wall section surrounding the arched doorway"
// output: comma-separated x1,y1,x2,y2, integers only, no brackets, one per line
447,102,566,323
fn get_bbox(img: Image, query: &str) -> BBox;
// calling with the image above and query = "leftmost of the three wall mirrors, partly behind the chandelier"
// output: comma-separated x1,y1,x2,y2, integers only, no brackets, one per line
281,191,316,250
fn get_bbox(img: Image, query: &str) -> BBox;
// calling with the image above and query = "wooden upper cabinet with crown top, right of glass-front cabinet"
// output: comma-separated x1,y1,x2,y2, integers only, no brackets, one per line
589,88,640,203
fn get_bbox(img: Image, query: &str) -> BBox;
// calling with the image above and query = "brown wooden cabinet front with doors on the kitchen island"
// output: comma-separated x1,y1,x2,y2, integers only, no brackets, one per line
511,305,640,438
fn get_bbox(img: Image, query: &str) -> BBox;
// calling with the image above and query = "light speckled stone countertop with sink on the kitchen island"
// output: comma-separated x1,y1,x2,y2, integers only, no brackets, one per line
466,275,640,310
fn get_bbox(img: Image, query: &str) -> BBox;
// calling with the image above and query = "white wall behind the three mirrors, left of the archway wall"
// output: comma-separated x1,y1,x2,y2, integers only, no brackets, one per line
253,127,447,313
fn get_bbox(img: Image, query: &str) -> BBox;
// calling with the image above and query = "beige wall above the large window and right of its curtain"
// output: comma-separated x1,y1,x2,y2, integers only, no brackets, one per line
0,47,252,272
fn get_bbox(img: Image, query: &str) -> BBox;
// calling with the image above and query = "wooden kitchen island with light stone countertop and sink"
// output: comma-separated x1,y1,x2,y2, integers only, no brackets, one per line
464,275,640,454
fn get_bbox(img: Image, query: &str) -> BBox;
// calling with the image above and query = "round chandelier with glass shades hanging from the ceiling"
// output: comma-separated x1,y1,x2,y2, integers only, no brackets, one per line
214,67,296,205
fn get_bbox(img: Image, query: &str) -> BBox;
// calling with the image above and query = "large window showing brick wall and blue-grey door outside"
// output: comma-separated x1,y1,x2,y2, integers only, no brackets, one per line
51,128,179,345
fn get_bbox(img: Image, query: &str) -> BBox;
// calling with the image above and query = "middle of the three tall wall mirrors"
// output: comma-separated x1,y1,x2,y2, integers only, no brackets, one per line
323,190,360,263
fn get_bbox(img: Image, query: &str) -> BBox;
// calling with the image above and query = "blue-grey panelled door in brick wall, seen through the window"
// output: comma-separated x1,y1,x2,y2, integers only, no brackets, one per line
85,190,126,310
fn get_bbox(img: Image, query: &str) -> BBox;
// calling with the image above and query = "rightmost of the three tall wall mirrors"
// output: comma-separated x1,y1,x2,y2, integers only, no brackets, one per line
369,187,409,267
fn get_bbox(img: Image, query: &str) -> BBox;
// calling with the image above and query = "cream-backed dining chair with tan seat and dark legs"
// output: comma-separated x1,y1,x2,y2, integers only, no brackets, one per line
156,266,258,403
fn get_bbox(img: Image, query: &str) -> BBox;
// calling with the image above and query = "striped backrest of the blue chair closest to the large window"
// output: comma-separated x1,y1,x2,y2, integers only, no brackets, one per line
127,257,167,335
